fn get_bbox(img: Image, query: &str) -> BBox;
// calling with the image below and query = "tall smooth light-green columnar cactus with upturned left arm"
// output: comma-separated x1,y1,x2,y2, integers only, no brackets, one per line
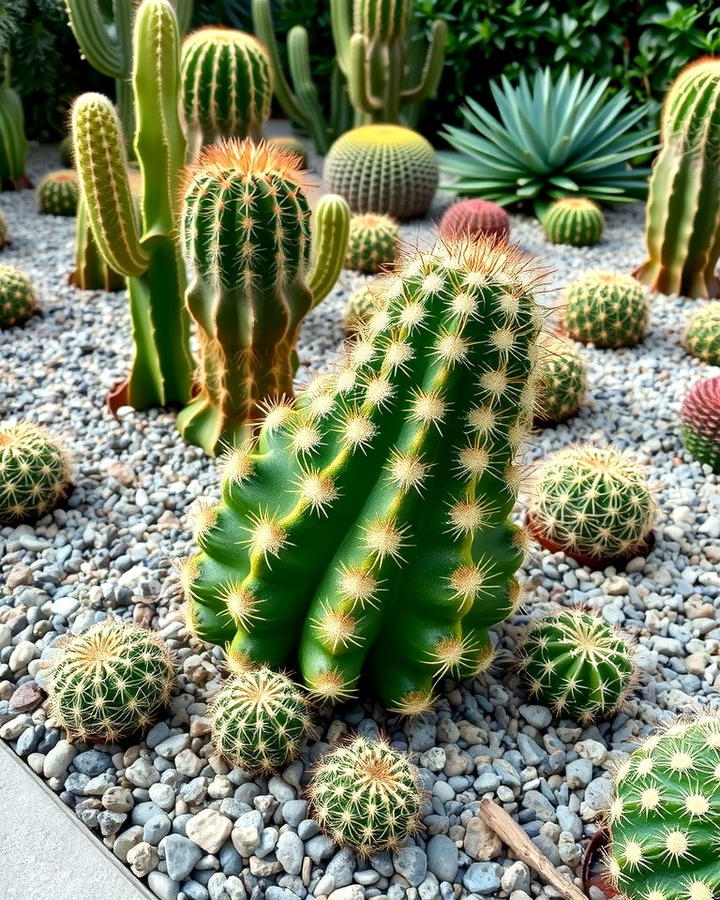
72,0,192,409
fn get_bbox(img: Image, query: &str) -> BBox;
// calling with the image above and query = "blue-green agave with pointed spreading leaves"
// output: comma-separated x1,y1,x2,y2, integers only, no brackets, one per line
441,66,655,218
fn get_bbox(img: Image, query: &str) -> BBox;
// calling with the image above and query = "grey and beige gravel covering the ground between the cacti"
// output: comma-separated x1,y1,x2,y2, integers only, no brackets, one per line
0,149,720,900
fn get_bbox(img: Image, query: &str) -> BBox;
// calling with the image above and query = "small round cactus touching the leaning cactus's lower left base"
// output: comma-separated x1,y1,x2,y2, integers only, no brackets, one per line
210,668,310,771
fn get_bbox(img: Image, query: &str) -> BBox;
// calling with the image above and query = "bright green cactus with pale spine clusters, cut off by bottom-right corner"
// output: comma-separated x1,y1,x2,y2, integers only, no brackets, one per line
608,716,720,900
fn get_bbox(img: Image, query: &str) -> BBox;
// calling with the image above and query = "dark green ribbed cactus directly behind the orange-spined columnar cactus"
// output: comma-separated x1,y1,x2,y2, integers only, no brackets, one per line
181,27,273,159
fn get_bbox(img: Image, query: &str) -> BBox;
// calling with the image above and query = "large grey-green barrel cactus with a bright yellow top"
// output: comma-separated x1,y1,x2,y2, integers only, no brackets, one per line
324,125,439,219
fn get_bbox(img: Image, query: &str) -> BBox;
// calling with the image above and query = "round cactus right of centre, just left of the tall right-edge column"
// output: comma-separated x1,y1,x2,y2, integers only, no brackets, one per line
563,272,650,347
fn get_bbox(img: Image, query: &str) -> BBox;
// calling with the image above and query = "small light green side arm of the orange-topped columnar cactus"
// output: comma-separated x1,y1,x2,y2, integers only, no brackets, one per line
308,194,350,306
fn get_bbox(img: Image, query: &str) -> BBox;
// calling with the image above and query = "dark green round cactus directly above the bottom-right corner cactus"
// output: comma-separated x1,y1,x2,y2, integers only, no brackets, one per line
518,609,635,725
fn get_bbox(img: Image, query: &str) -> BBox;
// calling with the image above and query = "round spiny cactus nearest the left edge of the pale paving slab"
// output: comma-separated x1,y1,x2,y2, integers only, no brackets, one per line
47,618,175,743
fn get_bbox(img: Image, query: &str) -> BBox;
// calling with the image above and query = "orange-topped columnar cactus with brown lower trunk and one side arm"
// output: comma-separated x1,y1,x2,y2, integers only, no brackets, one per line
177,139,350,454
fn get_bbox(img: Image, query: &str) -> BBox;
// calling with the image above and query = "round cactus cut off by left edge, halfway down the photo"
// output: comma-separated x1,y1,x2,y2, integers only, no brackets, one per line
0,422,70,525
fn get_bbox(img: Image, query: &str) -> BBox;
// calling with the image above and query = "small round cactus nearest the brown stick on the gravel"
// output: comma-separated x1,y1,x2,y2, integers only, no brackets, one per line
308,736,422,856
